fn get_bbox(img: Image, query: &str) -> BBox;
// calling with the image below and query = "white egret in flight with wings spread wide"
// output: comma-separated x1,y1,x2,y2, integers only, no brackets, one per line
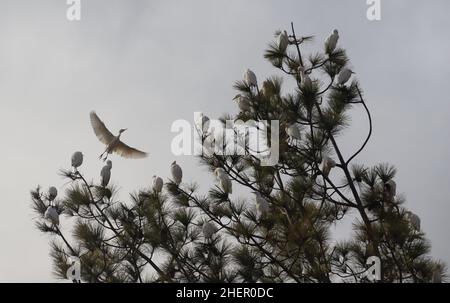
90,111,147,161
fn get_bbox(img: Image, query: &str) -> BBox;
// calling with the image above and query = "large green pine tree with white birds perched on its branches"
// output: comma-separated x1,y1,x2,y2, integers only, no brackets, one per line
31,25,446,282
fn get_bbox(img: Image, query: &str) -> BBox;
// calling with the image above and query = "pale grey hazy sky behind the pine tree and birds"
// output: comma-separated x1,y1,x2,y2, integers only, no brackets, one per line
0,0,450,282
